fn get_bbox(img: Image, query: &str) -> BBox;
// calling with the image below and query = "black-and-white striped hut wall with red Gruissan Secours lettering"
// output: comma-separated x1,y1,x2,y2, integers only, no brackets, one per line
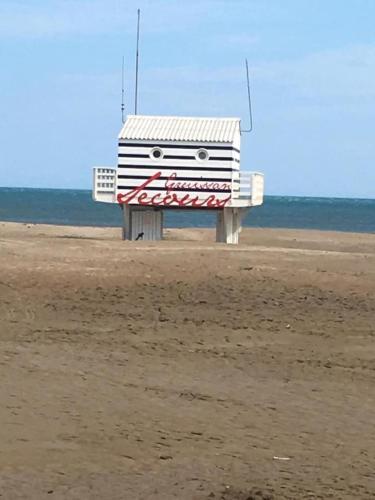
116,136,240,208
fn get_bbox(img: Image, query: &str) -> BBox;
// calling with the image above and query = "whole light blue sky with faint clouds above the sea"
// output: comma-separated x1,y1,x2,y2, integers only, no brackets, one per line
0,0,375,198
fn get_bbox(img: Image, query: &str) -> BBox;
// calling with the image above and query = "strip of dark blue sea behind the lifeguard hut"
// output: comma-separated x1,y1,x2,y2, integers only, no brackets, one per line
0,188,375,233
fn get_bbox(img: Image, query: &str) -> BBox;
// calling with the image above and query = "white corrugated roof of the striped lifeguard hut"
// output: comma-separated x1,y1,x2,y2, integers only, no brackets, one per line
119,115,240,142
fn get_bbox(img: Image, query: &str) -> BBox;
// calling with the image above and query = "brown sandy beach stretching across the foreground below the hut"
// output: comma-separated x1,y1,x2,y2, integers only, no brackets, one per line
0,223,375,500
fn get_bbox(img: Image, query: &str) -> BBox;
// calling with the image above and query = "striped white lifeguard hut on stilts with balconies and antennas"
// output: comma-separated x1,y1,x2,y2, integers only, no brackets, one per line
93,12,264,244
